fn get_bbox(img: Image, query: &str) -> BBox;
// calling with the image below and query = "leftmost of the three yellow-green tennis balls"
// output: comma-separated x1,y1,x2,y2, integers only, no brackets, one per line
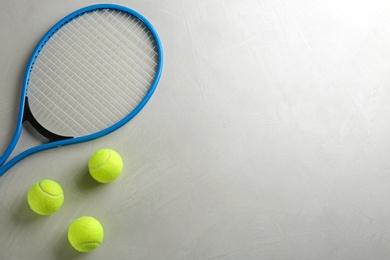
27,180,64,215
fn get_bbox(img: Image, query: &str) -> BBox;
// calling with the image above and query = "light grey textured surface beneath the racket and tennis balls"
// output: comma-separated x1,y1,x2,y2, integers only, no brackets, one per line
0,0,390,260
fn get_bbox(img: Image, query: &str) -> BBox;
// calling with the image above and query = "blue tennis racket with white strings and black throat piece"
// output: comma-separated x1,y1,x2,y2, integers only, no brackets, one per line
0,4,163,176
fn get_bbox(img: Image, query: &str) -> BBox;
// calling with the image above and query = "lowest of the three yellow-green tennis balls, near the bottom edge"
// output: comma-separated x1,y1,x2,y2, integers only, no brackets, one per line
68,216,104,252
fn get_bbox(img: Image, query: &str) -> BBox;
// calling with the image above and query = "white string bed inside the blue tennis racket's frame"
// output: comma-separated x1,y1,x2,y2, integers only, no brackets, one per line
29,10,158,137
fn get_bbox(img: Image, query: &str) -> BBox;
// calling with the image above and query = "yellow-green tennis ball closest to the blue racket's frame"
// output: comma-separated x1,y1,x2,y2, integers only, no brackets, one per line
88,149,123,183
